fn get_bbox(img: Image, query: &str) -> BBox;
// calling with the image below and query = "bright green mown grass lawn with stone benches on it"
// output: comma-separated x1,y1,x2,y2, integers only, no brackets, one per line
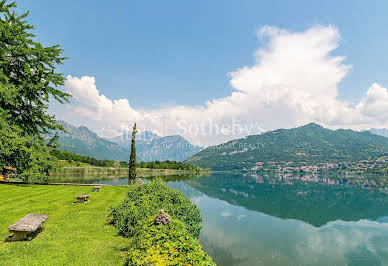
0,184,128,265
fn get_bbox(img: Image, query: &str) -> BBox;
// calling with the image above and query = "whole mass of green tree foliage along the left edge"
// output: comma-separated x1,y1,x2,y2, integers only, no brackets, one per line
0,0,70,182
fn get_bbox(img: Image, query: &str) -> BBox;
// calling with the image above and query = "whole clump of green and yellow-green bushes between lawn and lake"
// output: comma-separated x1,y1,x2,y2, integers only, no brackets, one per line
110,179,215,265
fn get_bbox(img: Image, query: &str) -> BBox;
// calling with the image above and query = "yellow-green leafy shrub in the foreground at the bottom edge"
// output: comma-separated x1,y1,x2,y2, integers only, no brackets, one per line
128,216,215,265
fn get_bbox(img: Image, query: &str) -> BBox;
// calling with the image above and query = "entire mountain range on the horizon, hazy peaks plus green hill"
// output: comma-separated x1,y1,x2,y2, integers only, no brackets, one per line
52,121,388,167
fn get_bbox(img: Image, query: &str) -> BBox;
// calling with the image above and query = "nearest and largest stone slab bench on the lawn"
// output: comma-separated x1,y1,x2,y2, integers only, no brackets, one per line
6,213,48,242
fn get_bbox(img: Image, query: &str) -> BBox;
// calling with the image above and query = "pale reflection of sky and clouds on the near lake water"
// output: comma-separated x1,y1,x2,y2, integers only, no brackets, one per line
196,195,388,265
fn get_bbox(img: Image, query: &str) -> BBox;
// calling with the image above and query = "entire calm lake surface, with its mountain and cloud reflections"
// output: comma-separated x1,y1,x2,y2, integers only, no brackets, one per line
53,173,388,265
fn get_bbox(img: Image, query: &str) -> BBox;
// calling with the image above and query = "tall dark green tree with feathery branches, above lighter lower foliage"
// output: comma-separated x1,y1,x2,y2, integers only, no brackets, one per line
0,0,70,135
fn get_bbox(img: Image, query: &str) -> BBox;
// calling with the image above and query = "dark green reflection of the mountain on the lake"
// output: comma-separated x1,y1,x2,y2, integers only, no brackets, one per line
186,173,388,227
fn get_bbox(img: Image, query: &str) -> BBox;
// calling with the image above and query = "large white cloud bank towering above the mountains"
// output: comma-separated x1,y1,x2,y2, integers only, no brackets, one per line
65,26,388,145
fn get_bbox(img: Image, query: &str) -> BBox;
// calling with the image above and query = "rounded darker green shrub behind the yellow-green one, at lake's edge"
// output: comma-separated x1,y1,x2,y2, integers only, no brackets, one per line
111,179,202,238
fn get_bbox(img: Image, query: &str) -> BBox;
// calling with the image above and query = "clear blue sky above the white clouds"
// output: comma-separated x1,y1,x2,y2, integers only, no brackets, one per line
17,0,388,145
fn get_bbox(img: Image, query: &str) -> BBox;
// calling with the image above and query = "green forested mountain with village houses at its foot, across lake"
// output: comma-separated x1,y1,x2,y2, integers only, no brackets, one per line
187,123,388,170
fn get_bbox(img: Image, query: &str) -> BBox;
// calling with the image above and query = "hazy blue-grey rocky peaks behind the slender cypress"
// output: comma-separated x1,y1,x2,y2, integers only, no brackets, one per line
50,121,203,162
